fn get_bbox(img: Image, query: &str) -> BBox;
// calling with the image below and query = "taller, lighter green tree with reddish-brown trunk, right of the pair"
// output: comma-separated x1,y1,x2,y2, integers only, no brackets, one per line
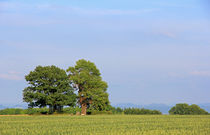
67,59,110,115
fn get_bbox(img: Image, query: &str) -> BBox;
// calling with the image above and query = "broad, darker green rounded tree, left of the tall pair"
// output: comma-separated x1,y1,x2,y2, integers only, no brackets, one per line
23,66,76,113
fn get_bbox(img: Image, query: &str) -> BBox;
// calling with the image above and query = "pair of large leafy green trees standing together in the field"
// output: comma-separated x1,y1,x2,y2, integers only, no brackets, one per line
23,59,110,115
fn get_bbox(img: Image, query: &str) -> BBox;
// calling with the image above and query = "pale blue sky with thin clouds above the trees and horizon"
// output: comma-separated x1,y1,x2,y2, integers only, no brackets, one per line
0,0,210,104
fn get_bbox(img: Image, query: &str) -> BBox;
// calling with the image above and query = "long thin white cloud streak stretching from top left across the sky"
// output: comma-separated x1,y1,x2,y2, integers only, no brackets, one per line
0,2,159,15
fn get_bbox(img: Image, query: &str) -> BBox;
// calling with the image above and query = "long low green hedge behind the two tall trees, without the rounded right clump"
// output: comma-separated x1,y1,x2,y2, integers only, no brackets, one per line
0,107,162,115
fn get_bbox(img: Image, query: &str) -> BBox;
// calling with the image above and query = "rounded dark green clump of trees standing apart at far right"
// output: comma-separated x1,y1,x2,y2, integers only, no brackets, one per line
169,103,208,115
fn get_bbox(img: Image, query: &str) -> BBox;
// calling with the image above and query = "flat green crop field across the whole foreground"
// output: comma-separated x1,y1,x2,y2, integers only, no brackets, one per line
0,115,210,135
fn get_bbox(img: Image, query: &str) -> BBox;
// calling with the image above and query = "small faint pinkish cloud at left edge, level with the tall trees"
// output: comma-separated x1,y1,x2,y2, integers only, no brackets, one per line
0,71,23,81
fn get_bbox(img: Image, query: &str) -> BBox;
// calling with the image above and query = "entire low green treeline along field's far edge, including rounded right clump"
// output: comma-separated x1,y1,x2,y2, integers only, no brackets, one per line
0,103,209,115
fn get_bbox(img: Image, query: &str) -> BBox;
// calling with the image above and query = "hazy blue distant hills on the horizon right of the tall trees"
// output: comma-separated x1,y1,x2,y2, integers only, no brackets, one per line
113,103,210,114
